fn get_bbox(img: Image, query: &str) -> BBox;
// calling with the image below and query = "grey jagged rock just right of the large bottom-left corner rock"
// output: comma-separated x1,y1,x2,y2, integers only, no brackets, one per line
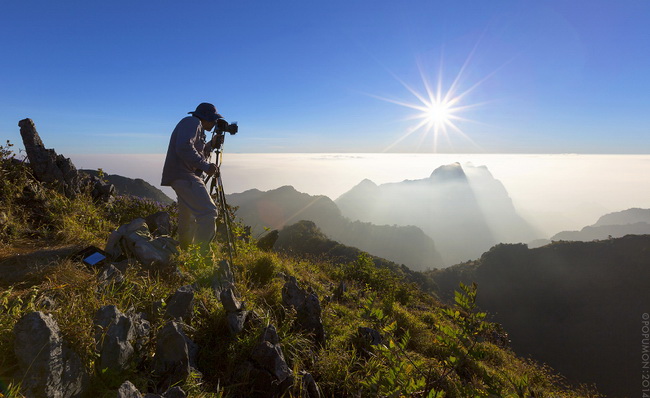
93,305,135,374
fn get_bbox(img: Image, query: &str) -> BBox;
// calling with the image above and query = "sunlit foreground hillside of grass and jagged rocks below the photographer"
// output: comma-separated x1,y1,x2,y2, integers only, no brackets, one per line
0,136,595,398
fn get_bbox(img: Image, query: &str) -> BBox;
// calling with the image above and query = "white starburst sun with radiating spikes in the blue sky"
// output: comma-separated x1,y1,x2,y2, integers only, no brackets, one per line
373,54,489,152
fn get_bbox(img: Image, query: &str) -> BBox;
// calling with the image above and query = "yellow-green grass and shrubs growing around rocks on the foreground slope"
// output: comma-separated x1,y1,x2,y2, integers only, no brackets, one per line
0,144,594,397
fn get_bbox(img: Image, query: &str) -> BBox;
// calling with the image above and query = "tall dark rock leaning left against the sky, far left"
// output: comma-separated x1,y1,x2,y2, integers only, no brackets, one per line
18,119,82,197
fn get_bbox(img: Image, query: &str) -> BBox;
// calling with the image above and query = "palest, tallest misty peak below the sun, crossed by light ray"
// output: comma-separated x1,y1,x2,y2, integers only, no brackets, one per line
335,163,539,265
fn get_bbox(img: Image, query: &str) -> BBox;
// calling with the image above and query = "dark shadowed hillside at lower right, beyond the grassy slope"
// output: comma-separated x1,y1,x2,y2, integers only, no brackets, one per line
432,235,650,397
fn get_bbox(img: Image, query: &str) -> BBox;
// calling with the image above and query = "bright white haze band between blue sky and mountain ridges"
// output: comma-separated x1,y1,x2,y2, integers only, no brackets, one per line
70,153,650,238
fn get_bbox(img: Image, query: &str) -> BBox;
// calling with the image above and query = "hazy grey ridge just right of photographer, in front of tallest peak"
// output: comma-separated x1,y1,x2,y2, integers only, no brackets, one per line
227,186,442,270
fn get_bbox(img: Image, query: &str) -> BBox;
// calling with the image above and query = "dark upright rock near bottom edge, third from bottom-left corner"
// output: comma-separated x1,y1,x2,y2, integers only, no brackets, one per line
153,321,190,391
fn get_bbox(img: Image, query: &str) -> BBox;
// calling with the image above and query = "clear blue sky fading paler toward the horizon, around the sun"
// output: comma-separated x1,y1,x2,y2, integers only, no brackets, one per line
0,0,650,154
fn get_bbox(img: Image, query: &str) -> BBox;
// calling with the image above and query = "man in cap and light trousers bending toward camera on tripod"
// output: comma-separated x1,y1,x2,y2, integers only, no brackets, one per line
161,102,222,253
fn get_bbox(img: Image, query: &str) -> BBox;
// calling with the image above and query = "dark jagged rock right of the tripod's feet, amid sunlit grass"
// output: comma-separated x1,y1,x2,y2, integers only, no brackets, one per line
282,276,325,344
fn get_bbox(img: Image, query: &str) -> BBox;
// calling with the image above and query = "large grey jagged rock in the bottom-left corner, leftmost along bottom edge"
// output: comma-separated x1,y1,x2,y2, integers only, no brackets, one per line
14,312,88,398
